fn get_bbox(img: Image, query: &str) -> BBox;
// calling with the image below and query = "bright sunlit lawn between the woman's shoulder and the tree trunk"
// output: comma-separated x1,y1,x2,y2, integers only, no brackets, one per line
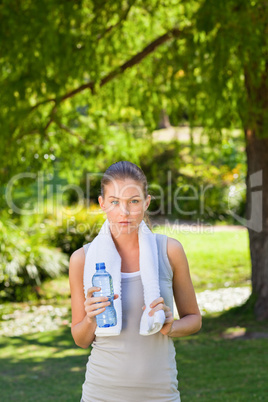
154,227,251,292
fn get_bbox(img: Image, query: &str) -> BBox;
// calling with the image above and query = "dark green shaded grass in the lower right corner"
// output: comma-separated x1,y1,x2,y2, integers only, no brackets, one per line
175,338,268,402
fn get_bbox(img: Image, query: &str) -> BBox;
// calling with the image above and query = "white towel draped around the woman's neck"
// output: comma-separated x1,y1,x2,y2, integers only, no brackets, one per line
84,219,165,336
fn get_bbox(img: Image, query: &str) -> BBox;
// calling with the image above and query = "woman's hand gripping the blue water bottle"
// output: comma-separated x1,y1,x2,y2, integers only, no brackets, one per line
84,286,119,323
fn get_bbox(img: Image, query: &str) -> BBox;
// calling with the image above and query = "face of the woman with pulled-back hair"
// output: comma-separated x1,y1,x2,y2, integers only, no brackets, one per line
99,179,151,235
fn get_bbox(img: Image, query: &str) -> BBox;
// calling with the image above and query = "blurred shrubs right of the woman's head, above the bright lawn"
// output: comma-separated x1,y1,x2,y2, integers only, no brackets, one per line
140,137,246,222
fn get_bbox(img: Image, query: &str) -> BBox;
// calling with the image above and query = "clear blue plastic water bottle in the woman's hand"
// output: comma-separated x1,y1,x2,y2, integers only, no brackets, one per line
92,262,117,328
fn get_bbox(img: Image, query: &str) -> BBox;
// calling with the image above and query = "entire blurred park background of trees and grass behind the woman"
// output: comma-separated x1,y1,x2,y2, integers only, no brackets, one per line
0,0,268,401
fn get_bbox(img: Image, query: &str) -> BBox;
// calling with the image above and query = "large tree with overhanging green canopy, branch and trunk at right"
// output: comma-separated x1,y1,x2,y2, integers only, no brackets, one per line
0,0,268,318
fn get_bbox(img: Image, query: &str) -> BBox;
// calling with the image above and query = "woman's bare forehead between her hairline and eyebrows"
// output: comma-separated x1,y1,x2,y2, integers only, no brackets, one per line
105,179,143,197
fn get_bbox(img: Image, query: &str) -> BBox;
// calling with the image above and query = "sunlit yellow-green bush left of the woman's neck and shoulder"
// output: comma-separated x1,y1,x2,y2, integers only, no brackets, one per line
0,206,104,301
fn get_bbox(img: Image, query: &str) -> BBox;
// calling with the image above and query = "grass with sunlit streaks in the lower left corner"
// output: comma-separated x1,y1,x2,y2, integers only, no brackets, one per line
0,327,89,402
